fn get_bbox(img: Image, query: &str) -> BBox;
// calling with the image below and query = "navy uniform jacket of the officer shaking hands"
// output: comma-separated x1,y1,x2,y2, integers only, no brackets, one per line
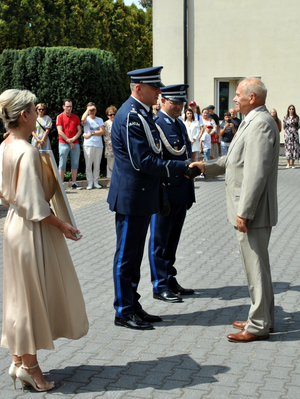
107,96,185,216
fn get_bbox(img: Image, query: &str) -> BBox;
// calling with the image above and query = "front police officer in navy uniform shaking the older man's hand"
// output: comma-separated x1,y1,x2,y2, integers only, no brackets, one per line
107,67,199,329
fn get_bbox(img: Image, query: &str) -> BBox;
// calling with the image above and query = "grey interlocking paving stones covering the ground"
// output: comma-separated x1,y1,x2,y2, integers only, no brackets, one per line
0,160,300,399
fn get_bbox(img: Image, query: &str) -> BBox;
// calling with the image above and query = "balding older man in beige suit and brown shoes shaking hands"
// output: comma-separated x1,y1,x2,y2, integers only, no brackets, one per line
190,78,279,342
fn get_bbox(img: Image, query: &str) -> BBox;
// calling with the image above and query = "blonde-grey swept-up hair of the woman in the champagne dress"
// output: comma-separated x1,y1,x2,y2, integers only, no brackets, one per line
0,89,36,128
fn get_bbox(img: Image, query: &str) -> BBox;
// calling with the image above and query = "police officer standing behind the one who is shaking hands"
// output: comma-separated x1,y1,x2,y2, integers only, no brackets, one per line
149,84,195,302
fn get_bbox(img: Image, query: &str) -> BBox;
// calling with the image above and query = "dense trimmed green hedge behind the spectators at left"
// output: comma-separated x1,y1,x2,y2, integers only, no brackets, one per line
0,47,125,172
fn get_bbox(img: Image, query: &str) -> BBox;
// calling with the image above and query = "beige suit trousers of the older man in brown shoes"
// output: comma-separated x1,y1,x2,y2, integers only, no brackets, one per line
235,226,274,335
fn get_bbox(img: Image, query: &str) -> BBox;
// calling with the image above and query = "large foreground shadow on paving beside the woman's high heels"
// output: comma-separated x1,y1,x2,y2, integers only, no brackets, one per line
27,354,230,395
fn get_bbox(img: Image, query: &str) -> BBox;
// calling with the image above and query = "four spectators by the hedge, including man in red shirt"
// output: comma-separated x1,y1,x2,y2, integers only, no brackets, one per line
31,98,117,190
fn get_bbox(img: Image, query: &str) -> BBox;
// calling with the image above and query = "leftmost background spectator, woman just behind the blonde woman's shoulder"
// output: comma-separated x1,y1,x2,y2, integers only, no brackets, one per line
31,103,52,150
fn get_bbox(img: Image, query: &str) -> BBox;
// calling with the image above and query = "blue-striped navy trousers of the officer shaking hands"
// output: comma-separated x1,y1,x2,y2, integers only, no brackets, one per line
113,213,151,318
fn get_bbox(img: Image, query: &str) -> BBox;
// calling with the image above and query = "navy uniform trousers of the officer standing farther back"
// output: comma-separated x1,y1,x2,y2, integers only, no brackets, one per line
149,204,187,293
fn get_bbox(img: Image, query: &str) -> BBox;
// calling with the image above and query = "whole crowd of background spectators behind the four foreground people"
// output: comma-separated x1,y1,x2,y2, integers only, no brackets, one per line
18,90,300,190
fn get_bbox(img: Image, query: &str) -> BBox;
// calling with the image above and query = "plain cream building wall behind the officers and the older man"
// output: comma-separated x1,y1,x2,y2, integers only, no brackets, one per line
153,0,300,141
